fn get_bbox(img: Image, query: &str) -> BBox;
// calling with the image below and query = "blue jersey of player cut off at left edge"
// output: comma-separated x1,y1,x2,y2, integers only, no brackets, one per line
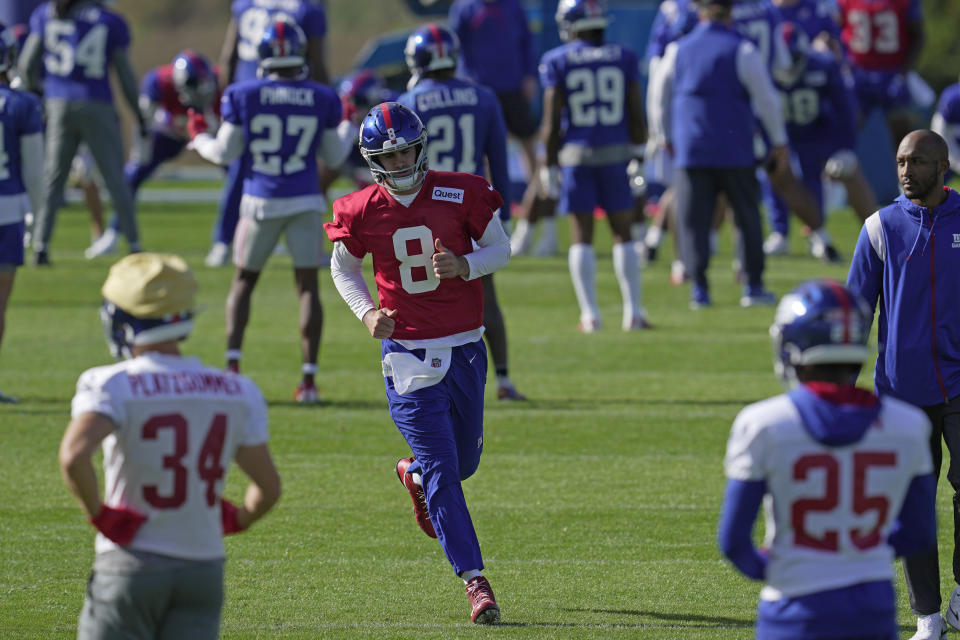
0,85,43,197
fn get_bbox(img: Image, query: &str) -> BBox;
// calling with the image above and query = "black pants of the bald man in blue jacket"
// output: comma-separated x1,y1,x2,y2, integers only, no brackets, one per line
903,396,960,616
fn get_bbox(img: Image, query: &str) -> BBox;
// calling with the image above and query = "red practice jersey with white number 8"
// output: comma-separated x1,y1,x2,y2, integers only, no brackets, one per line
323,171,503,340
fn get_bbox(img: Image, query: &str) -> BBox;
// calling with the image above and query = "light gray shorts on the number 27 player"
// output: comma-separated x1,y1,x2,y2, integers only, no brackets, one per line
233,211,323,272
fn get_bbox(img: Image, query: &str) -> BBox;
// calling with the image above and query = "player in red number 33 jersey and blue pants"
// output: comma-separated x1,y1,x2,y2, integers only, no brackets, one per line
837,0,925,149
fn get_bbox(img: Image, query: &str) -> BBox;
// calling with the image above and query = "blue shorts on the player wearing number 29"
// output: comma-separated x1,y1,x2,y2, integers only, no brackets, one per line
559,162,633,215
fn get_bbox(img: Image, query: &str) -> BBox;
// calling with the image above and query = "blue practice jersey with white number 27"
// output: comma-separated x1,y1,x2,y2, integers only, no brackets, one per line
220,79,341,198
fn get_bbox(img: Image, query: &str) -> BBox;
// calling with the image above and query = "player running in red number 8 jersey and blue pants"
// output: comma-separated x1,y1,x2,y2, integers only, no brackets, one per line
324,102,510,624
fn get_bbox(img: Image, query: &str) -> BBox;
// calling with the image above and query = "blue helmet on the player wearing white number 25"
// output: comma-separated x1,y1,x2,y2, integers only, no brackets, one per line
770,280,873,382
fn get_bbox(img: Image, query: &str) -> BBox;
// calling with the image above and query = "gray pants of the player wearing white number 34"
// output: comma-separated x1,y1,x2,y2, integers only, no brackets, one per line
77,551,224,640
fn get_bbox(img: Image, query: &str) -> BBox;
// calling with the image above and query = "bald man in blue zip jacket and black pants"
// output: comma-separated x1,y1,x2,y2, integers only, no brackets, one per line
847,130,960,640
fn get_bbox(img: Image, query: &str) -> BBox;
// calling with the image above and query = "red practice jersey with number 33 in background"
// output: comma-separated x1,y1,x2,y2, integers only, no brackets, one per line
837,0,922,71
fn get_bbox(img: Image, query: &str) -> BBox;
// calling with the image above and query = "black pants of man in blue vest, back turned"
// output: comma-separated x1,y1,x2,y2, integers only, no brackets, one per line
673,167,764,289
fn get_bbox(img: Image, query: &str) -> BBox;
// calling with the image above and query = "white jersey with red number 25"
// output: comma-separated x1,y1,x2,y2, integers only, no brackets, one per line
724,393,932,600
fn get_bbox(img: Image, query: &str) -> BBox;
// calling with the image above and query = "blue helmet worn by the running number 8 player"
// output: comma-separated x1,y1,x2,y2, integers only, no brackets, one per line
360,102,427,192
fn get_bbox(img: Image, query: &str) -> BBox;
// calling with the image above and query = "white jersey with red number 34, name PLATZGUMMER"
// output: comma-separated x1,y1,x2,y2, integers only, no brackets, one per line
71,353,267,560
